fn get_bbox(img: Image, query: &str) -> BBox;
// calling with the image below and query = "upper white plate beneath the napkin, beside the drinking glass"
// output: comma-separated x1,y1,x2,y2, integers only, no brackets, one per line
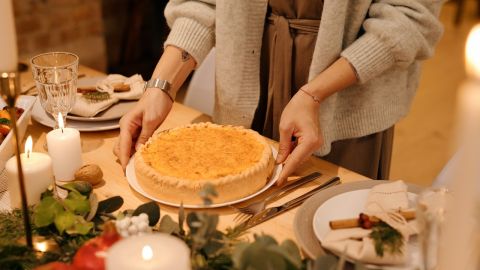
67,76,137,122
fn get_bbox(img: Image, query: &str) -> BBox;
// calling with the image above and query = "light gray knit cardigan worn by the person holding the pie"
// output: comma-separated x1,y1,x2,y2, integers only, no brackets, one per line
165,0,443,156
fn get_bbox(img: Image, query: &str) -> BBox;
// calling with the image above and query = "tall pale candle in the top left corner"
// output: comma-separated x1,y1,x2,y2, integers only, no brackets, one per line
0,0,18,72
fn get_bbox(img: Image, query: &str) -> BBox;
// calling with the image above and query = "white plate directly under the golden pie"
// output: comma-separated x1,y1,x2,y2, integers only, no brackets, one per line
126,147,282,208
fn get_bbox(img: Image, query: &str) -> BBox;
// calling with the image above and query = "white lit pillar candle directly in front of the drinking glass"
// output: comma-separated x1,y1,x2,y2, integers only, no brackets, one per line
47,113,82,181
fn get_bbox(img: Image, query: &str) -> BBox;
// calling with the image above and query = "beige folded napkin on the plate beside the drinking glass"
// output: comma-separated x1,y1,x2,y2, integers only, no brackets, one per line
70,74,145,117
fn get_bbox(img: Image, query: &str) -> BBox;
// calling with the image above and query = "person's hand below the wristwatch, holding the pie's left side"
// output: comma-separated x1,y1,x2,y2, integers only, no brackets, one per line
114,88,173,170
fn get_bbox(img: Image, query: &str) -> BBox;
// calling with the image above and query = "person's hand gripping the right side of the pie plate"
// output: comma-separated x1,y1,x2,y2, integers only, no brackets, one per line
276,91,323,185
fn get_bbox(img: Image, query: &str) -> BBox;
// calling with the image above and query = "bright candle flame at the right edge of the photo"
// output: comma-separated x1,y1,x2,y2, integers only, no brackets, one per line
465,24,480,80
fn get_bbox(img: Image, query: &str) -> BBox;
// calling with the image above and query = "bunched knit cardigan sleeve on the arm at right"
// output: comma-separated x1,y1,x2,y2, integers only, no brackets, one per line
341,0,443,83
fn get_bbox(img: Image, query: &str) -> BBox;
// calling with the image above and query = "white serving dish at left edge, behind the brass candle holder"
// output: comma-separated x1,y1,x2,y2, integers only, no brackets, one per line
0,96,35,171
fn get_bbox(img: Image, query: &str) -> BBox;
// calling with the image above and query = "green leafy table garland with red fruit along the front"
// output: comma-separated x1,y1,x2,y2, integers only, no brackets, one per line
0,181,363,270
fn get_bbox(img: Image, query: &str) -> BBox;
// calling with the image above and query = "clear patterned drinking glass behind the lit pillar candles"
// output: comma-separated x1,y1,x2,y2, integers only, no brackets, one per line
31,52,78,127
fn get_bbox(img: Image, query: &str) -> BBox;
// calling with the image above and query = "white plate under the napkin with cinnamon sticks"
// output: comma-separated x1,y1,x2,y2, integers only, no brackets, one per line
313,189,420,269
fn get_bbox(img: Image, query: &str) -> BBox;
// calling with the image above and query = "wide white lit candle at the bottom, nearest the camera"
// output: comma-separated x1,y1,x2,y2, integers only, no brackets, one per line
105,233,191,270
